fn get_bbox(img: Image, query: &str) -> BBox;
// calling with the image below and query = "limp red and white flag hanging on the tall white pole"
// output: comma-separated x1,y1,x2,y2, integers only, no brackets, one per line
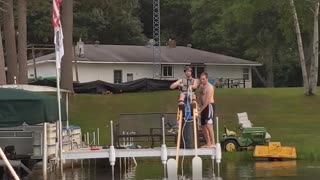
52,0,64,69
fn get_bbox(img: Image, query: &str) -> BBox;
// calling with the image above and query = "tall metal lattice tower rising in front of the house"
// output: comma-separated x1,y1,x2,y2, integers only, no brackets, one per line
153,0,162,79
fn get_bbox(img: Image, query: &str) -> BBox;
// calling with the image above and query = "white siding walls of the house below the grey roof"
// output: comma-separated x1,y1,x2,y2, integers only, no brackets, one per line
28,62,252,88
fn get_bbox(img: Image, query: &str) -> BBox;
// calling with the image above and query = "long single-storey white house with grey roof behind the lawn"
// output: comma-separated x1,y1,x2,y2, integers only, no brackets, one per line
28,43,261,88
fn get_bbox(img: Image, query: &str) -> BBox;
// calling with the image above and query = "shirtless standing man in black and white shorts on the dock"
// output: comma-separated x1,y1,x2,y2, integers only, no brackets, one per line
199,72,215,148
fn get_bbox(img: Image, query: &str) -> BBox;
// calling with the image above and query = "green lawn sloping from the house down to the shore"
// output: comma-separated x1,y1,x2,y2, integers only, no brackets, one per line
70,88,320,160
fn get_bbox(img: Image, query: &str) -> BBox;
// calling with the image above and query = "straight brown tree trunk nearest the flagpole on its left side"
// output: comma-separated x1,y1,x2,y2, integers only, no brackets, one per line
18,0,28,84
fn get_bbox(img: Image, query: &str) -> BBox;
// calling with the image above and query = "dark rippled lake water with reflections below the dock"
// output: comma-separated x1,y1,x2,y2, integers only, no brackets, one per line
20,159,320,180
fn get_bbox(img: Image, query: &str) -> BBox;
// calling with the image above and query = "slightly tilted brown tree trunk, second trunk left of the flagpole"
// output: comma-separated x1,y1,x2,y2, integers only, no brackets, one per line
4,0,18,84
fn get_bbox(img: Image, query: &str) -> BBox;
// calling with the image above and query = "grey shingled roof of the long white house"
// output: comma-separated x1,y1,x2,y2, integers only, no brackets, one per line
30,44,261,66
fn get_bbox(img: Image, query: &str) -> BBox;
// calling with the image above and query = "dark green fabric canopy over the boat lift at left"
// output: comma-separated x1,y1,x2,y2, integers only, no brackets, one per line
0,88,67,127
